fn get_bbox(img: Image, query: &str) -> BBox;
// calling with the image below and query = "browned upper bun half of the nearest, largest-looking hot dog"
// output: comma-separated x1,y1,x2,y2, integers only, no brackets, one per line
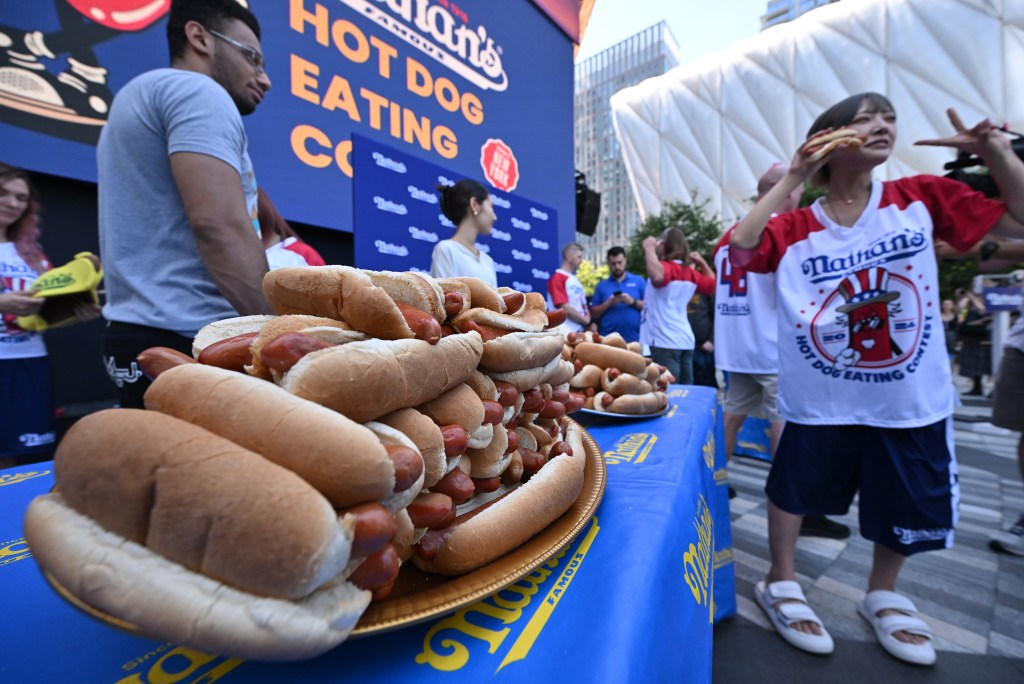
44,409,353,599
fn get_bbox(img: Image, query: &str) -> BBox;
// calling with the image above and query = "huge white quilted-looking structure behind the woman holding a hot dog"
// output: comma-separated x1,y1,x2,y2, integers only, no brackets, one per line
611,0,1024,225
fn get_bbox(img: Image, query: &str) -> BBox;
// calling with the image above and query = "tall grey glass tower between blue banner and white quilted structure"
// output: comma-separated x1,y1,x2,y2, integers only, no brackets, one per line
574,22,679,265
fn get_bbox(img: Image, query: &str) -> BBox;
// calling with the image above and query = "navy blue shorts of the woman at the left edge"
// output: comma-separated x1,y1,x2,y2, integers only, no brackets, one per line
0,356,54,457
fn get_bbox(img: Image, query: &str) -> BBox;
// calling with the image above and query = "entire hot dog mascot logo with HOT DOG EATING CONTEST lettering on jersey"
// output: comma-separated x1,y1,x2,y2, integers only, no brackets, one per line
796,266,933,382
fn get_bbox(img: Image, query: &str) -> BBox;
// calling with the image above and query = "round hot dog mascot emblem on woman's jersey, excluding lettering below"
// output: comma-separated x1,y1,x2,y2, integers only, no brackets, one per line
813,267,922,369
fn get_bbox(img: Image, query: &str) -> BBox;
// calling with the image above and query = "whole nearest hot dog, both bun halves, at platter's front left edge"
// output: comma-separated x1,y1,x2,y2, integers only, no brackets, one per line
25,410,370,659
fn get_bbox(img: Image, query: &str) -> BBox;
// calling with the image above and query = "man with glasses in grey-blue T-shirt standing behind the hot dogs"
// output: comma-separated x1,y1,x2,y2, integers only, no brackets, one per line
96,0,270,407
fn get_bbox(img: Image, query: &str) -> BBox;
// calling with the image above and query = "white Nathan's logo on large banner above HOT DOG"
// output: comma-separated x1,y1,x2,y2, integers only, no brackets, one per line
341,0,509,92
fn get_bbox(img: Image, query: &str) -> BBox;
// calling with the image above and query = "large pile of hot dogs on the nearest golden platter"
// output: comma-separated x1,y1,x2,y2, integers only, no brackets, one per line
26,266,589,659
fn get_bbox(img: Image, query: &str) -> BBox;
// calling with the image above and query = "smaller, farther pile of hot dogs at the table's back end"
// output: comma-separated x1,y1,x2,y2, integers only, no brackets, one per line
566,332,675,416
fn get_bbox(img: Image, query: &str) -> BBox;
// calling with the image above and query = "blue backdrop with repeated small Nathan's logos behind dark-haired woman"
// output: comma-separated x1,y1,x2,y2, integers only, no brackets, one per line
352,135,561,294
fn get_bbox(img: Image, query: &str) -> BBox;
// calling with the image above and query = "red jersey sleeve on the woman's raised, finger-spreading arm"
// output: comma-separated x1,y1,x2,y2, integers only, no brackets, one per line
882,175,1007,252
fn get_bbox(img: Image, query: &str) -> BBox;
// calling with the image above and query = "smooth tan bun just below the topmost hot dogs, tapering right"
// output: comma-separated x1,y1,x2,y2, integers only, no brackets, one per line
280,331,483,423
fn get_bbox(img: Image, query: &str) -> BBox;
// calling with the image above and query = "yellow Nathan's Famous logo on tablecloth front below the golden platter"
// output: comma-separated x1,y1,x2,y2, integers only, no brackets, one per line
416,517,601,672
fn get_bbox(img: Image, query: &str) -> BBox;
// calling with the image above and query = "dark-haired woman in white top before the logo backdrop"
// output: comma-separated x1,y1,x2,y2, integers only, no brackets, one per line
430,179,498,288
